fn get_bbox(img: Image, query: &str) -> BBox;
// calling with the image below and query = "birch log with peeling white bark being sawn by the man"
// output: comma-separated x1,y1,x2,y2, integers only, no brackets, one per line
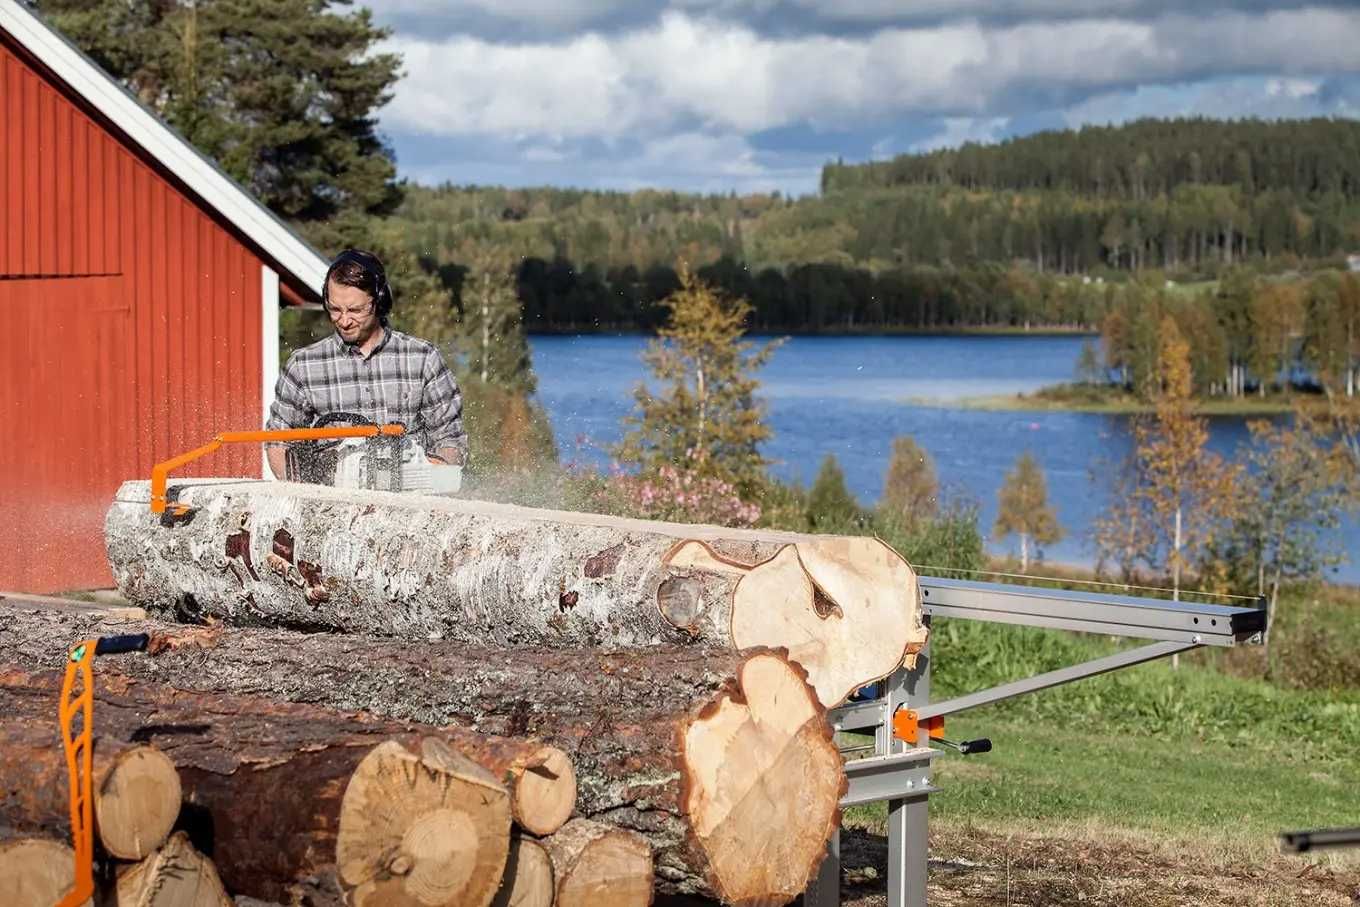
105,480,926,707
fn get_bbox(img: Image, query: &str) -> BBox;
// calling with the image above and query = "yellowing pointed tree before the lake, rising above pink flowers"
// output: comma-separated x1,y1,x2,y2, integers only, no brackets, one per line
615,267,778,500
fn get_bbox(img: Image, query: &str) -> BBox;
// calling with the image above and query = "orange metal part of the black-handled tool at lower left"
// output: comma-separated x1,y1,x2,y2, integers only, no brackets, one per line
57,639,95,907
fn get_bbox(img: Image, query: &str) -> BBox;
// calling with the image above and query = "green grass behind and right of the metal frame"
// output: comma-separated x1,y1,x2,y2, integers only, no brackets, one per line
846,587,1360,853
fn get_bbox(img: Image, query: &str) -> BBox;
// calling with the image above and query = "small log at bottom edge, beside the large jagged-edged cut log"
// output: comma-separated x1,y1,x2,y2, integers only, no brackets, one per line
543,819,651,907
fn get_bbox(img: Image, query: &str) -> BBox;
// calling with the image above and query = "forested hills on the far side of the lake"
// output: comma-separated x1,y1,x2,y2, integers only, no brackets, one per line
393,120,1360,333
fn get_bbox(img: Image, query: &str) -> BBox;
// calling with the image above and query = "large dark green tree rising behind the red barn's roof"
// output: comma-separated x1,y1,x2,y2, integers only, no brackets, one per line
35,0,401,223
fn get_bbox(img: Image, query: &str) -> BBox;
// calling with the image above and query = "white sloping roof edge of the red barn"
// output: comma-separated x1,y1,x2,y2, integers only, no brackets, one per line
0,0,329,294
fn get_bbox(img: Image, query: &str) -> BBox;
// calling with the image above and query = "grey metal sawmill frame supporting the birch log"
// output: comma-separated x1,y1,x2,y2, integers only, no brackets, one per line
804,577,1266,907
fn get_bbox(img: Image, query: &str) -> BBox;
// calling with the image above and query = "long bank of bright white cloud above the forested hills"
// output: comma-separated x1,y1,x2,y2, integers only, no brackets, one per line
384,10,1360,140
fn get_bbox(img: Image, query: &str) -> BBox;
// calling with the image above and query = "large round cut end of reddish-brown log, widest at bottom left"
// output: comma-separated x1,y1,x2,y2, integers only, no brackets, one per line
336,738,510,907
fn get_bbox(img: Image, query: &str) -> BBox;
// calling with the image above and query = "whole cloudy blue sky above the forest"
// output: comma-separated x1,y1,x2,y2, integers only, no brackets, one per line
367,0,1360,196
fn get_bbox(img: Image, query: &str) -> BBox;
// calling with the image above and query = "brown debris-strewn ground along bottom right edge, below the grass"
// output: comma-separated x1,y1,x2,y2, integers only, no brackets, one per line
840,824,1360,907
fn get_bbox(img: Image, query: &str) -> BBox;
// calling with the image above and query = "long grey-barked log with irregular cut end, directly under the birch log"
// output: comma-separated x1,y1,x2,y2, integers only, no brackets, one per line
0,612,845,903
